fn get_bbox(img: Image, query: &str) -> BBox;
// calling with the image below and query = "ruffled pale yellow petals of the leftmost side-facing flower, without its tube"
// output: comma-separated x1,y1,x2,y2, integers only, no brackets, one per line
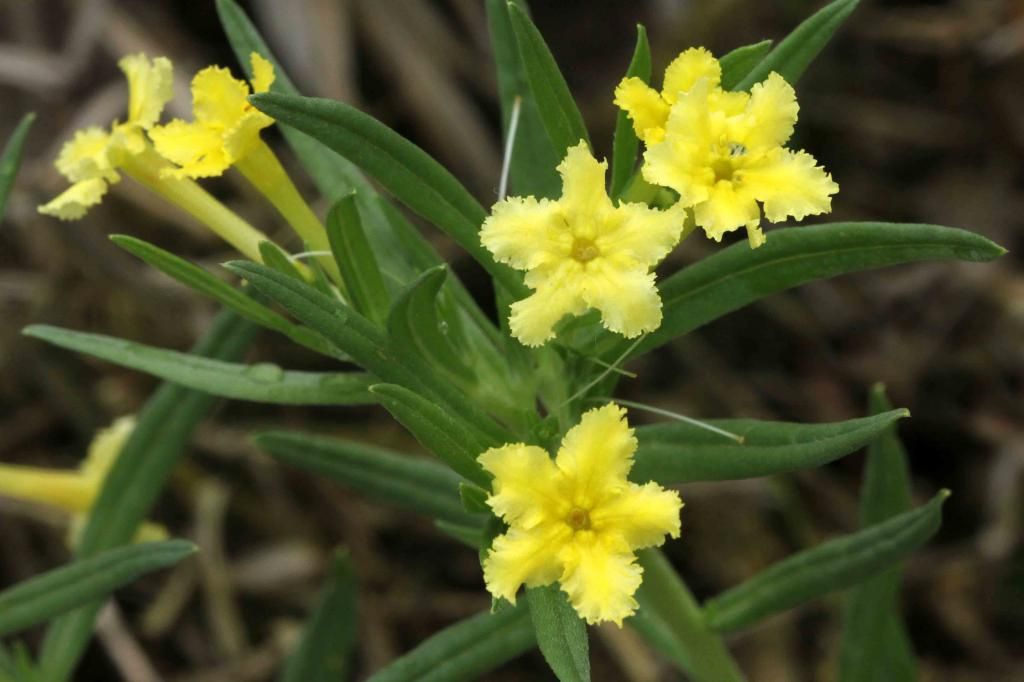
39,54,172,220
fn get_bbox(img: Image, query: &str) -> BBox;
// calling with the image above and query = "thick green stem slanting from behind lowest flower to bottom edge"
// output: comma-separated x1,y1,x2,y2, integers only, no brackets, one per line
637,549,745,682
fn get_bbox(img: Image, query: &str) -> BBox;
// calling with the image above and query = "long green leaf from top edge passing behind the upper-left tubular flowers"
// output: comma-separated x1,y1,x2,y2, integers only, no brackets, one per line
217,0,416,284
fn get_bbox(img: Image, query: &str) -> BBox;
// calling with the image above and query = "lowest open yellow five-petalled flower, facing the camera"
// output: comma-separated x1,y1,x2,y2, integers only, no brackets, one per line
479,404,683,626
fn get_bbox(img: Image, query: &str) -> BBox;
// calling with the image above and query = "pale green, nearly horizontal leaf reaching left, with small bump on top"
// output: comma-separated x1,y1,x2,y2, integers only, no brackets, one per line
22,325,374,404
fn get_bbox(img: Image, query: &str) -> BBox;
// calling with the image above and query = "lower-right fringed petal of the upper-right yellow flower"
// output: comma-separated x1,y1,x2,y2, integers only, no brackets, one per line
742,148,839,222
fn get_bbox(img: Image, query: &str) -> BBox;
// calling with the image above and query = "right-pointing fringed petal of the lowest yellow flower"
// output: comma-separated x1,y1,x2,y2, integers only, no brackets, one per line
590,483,683,549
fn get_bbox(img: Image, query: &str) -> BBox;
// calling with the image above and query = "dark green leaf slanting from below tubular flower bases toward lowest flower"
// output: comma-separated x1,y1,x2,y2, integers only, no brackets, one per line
225,261,512,452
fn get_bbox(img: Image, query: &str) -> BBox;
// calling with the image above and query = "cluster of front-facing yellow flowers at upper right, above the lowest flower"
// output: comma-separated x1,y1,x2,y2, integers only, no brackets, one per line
480,48,839,346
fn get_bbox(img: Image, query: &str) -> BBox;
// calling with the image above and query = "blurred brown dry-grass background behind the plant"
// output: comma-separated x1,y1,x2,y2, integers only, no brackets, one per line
0,0,1024,682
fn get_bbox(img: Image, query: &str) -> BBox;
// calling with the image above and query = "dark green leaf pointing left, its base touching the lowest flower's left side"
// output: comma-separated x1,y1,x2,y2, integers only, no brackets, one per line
254,431,479,525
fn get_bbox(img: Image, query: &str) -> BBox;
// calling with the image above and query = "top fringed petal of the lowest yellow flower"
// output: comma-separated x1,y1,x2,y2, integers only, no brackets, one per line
555,403,637,499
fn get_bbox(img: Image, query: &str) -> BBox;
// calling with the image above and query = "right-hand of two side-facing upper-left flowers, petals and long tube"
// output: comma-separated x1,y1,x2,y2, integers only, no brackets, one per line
150,52,343,280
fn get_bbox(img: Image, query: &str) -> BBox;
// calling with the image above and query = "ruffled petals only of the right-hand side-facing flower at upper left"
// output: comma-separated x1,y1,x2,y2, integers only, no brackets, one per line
150,52,273,178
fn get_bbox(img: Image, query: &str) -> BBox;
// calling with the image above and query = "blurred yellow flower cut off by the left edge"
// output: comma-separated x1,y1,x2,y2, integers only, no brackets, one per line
0,416,167,545
